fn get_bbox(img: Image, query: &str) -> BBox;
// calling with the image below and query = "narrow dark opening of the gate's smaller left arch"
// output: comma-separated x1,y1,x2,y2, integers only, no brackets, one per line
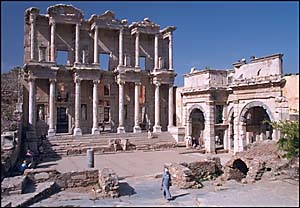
189,108,205,147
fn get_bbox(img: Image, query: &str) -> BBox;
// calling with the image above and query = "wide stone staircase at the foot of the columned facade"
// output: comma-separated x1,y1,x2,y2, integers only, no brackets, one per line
43,132,182,158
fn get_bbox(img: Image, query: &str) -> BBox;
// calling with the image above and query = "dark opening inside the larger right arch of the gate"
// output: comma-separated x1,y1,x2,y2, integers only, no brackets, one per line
243,106,273,145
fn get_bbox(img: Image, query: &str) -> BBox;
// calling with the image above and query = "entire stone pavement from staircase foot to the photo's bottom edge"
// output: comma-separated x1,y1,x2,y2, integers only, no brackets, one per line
32,150,299,207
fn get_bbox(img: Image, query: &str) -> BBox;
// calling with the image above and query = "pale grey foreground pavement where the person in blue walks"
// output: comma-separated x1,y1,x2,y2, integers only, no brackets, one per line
32,177,299,207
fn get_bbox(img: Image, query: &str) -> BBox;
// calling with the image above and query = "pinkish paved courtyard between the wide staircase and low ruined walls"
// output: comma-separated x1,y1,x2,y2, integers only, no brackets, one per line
38,149,231,177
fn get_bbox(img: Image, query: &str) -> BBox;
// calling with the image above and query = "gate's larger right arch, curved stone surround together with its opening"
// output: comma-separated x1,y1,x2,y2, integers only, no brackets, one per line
240,101,274,145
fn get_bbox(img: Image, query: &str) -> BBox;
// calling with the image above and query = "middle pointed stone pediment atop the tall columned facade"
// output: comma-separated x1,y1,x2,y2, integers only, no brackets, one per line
89,10,127,28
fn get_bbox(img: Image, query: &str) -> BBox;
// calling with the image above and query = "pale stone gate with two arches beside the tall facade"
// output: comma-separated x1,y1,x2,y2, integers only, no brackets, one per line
176,54,289,152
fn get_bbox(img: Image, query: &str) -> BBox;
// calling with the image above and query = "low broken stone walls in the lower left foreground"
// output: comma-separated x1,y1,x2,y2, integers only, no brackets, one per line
1,168,119,206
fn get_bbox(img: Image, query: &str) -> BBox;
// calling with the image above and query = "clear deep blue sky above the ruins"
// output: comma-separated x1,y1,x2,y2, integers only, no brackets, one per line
1,1,299,86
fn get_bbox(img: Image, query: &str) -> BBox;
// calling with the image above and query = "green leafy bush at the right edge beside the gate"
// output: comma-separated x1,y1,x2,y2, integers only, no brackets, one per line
270,120,299,159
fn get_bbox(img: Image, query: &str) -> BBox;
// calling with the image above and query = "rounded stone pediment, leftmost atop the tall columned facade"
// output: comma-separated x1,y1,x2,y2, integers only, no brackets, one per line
47,4,83,19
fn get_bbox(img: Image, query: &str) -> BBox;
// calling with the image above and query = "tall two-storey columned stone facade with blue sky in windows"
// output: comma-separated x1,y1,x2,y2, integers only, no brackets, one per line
23,4,176,143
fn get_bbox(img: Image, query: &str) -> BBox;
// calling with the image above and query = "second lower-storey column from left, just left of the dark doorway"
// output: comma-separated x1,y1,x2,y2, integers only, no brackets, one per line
48,79,56,137
